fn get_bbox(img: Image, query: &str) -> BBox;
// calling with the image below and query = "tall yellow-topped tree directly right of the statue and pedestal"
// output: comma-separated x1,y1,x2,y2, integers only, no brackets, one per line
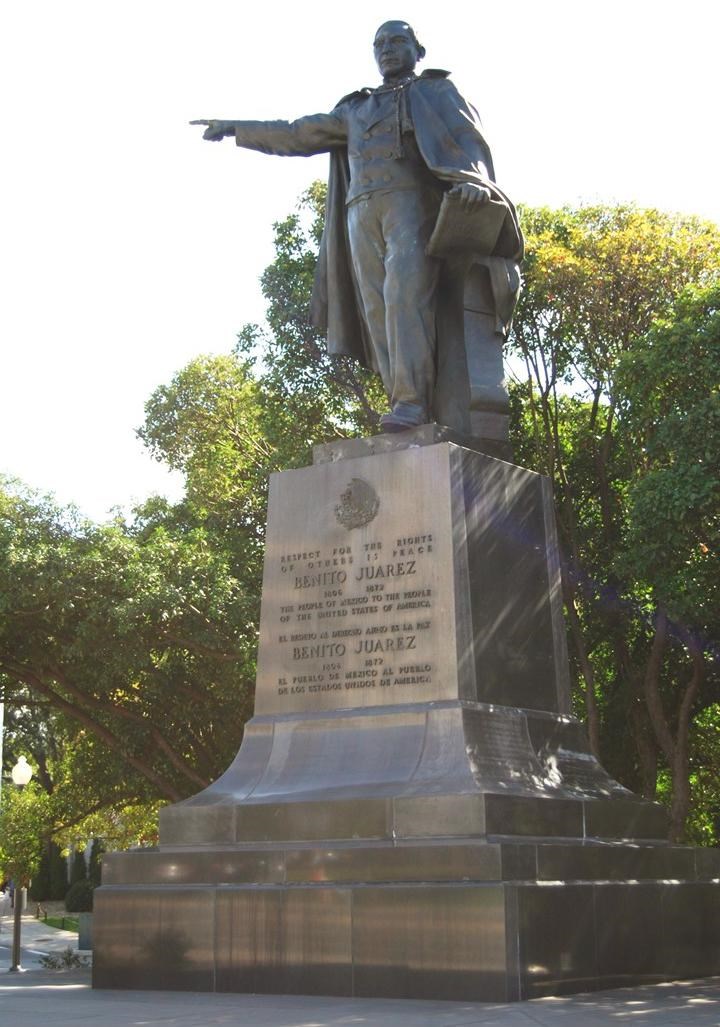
505,206,720,836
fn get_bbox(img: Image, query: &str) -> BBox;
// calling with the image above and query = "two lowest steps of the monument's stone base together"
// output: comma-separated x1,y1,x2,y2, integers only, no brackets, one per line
93,840,720,1001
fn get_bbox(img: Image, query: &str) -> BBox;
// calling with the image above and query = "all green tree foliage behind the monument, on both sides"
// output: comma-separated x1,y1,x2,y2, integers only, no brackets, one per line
0,185,720,846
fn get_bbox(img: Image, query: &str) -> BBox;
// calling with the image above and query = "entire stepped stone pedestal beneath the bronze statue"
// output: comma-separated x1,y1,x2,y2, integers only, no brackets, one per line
93,426,720,1001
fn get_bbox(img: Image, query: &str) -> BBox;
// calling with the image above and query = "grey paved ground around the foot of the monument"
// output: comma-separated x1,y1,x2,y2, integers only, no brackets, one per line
0,917,720,1027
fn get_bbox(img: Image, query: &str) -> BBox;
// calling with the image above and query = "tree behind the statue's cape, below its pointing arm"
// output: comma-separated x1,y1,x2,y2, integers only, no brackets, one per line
139,183,386,521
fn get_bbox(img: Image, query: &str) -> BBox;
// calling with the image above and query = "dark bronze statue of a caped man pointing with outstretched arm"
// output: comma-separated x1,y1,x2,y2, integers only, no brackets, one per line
194,22,523,434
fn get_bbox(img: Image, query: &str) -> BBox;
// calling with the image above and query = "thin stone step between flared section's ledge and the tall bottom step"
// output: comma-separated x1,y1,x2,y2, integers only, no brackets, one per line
103,838,720,893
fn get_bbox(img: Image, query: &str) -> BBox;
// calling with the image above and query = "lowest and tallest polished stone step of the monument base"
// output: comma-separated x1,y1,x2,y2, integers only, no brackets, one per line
93,875,720,1001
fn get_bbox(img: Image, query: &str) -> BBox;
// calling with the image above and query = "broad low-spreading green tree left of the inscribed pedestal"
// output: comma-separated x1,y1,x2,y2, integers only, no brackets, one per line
0,483,257,812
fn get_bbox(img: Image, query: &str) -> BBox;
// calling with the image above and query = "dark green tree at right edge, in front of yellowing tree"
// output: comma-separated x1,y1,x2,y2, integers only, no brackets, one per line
617,283,720,837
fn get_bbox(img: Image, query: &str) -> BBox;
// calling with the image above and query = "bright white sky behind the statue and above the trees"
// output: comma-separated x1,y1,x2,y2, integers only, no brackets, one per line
0,0,720,519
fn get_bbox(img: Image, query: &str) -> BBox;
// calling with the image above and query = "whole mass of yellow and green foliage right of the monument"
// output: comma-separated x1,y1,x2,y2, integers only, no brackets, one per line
513,206,720,837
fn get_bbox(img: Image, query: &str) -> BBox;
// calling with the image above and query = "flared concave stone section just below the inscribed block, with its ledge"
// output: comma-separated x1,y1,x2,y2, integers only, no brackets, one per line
161,701,667,847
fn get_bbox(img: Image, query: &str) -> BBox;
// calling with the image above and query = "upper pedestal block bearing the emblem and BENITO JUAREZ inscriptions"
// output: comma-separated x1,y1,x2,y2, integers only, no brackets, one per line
187,441,569,716
